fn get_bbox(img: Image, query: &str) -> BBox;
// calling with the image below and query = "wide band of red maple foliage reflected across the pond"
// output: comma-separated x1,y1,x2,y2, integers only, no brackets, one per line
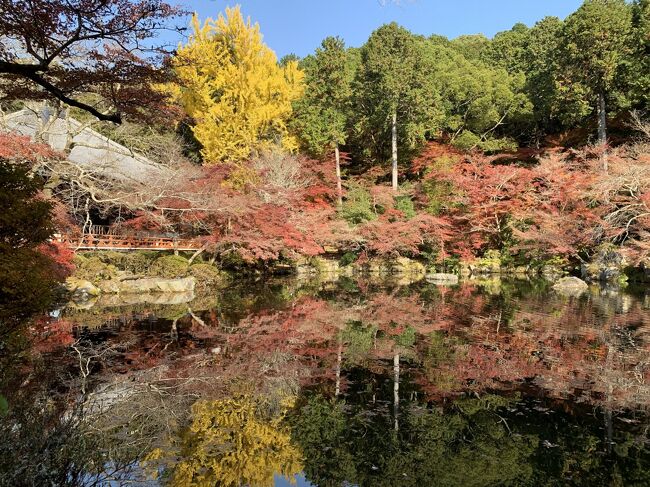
41,286,650,405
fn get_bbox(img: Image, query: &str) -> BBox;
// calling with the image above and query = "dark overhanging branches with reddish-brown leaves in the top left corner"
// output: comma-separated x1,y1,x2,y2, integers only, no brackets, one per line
0,0,184,123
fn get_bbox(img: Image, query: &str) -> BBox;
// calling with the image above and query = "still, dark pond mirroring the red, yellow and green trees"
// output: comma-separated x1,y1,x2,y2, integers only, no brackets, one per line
3,278,650,486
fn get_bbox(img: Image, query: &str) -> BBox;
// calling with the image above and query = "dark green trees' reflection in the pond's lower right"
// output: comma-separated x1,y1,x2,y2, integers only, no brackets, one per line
292,394,650,486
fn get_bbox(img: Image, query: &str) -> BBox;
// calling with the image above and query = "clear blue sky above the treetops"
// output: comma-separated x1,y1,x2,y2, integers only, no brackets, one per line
172,0,582,57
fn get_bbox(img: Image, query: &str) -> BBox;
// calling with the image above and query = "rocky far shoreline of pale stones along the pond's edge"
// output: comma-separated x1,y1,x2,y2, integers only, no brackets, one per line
66,246,650,303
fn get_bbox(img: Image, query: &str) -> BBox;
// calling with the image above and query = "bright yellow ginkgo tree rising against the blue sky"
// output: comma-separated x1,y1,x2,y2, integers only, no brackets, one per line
172,6,304,163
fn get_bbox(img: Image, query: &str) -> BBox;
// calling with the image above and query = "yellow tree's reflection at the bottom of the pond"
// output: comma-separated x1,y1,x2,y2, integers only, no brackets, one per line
150,398,302,487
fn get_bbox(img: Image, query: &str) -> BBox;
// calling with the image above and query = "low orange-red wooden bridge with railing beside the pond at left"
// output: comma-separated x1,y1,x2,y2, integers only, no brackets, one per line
54,226,201,254
